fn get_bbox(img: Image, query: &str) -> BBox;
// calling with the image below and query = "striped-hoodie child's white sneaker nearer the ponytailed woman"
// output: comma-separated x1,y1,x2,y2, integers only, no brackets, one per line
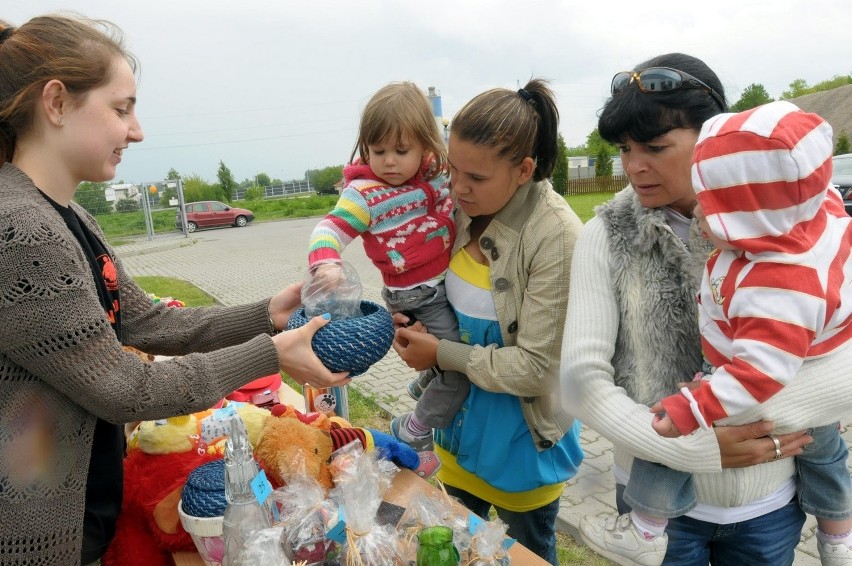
580,513,669,566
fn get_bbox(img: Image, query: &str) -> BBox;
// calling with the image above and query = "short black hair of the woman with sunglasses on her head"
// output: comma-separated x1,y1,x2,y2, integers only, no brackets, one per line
598,53,727,143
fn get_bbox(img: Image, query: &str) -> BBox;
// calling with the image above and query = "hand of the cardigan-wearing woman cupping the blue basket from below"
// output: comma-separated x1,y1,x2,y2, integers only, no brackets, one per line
272,316,352,389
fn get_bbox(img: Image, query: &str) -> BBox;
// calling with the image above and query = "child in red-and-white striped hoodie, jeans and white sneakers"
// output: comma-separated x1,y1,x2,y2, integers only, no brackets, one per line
596,101,852,566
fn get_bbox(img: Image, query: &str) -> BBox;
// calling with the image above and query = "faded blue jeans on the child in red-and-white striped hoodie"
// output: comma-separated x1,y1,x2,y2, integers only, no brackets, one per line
624,423,852,519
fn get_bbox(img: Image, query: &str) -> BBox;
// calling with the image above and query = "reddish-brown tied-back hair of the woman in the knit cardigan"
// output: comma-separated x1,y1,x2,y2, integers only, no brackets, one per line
0,15,139,163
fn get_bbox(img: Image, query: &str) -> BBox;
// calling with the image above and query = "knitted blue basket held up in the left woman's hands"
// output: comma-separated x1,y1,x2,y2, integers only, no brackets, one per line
287,301,394,377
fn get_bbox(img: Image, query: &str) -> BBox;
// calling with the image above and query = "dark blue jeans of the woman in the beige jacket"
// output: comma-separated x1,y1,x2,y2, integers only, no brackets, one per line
444,485,559,566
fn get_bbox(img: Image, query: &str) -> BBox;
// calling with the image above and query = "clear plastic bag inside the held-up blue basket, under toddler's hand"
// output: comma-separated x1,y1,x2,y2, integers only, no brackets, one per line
302,260,362,320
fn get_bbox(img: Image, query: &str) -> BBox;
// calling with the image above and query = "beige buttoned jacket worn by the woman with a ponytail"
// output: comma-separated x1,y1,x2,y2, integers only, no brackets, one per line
438,181,582,450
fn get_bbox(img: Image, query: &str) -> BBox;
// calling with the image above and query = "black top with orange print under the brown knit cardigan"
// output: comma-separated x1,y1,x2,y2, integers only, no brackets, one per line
42,193,125,564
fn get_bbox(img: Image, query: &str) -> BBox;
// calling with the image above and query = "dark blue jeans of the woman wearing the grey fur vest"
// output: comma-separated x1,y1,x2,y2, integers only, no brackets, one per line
616,484,805,566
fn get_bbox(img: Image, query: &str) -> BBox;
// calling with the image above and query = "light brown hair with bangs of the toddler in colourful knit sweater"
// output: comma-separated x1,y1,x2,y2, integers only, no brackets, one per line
352,82,447,180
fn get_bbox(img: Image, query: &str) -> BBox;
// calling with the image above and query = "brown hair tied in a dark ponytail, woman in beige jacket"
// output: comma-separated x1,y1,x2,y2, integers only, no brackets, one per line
451,79,559,181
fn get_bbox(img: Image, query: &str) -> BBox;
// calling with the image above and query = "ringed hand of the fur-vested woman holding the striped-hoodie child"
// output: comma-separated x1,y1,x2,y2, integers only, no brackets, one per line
713,421,814,468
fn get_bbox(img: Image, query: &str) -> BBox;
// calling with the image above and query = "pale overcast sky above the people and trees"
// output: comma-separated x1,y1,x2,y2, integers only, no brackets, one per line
8,0,852,182
